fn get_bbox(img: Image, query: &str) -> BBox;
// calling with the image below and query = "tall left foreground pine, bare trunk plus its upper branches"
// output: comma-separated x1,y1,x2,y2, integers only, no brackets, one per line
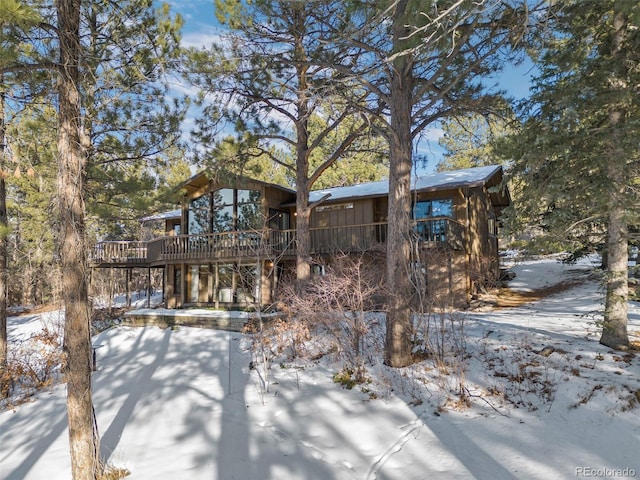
0,0,186,478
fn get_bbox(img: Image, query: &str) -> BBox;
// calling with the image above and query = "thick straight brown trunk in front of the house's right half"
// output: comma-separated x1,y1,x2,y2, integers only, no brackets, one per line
385,1,413,367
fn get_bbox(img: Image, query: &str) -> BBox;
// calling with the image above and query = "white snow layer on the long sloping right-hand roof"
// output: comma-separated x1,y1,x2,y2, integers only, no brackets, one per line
309,165,502,202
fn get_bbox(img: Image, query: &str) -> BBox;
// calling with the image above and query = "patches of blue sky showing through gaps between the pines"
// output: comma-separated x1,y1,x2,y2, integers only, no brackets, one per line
169,0,532,171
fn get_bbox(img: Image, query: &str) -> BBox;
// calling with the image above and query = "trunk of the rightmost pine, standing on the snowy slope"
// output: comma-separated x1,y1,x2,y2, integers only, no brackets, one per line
600,12,629,350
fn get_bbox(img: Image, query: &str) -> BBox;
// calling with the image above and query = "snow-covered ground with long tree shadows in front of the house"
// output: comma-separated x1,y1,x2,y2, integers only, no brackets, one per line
0,259,640,480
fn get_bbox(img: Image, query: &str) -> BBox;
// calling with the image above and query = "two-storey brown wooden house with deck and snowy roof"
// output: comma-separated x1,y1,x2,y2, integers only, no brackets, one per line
91,165,510,308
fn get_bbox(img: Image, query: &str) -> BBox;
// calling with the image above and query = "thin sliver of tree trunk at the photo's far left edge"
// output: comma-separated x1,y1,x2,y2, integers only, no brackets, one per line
0,85,9,398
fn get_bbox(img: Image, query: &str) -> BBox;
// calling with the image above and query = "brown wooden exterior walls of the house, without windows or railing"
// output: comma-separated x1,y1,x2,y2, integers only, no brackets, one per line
99,171,510,308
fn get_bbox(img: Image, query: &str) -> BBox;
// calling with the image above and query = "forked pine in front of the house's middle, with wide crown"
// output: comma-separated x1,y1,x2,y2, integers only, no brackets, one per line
187,0,367,282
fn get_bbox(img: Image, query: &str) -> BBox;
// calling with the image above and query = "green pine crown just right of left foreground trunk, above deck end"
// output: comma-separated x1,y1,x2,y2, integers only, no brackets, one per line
81,0,185,239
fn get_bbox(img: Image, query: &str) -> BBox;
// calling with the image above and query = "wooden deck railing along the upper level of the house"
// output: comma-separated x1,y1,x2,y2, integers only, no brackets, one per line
91,217,464,265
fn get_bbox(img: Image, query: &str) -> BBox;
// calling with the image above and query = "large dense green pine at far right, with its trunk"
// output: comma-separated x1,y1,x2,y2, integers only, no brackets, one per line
514,0,640,349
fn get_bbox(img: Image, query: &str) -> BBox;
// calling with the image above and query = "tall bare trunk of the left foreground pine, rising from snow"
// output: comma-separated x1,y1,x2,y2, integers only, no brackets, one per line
56,0,100,480
